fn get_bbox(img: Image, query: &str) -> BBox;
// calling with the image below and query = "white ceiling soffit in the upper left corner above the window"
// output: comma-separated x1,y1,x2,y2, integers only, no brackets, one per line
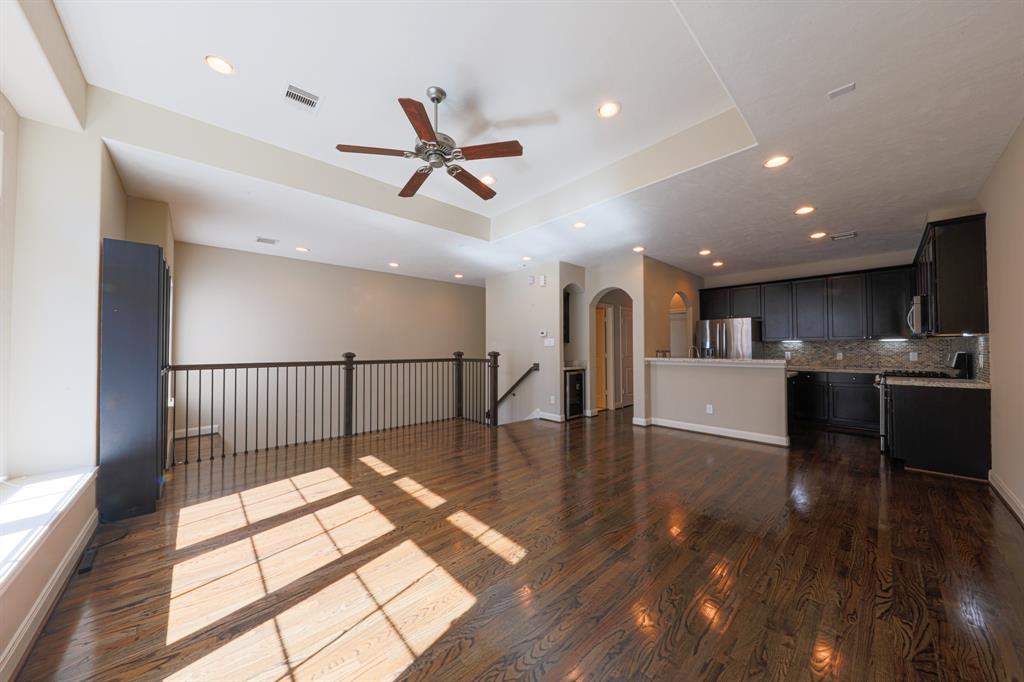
0,0,86,131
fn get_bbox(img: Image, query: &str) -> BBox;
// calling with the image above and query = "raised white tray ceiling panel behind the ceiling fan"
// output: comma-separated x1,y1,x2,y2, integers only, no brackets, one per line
57,0,737,224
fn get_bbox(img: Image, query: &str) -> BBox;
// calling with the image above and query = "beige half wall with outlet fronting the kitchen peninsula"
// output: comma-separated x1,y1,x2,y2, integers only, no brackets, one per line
648,360,790,445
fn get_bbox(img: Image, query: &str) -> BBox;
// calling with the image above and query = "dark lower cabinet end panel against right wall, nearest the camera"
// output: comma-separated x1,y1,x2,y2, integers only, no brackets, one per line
887,385,992,479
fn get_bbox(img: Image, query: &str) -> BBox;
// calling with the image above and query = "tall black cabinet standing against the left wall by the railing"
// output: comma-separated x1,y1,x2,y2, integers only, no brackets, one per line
96,240,171,521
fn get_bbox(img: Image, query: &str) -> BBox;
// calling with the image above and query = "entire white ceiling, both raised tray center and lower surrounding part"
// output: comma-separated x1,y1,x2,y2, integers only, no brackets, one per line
58,0,1024,283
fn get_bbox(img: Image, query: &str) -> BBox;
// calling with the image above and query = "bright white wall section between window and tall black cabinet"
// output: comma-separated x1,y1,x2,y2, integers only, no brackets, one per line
8,119,104,476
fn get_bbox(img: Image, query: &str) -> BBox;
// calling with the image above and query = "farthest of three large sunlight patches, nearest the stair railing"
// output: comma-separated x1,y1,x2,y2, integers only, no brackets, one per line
174,467,352,549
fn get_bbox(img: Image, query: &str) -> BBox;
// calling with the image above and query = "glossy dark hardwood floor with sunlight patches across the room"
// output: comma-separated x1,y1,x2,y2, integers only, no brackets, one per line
19,411,1024,681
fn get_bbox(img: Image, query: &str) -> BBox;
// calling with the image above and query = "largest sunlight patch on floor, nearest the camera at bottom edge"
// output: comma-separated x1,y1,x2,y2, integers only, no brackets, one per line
165,540,476,682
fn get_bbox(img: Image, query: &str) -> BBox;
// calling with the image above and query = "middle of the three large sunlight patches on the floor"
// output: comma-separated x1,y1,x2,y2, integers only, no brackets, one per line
167,496,394,644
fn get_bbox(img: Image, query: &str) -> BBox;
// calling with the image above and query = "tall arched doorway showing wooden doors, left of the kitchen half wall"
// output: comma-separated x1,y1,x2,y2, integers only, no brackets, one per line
590,288,635,412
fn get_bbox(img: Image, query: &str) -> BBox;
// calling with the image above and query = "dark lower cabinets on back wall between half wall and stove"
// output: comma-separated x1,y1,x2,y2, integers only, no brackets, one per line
788,372,880,431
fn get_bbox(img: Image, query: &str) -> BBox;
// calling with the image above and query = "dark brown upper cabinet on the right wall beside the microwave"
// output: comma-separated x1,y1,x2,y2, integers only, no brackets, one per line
913,214,988,335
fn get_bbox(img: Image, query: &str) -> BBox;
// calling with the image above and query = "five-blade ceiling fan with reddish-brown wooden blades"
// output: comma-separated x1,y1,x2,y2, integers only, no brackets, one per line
338,85,522,201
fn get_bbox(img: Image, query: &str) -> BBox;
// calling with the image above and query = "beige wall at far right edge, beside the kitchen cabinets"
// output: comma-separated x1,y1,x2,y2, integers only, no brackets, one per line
978,118,1024,520
